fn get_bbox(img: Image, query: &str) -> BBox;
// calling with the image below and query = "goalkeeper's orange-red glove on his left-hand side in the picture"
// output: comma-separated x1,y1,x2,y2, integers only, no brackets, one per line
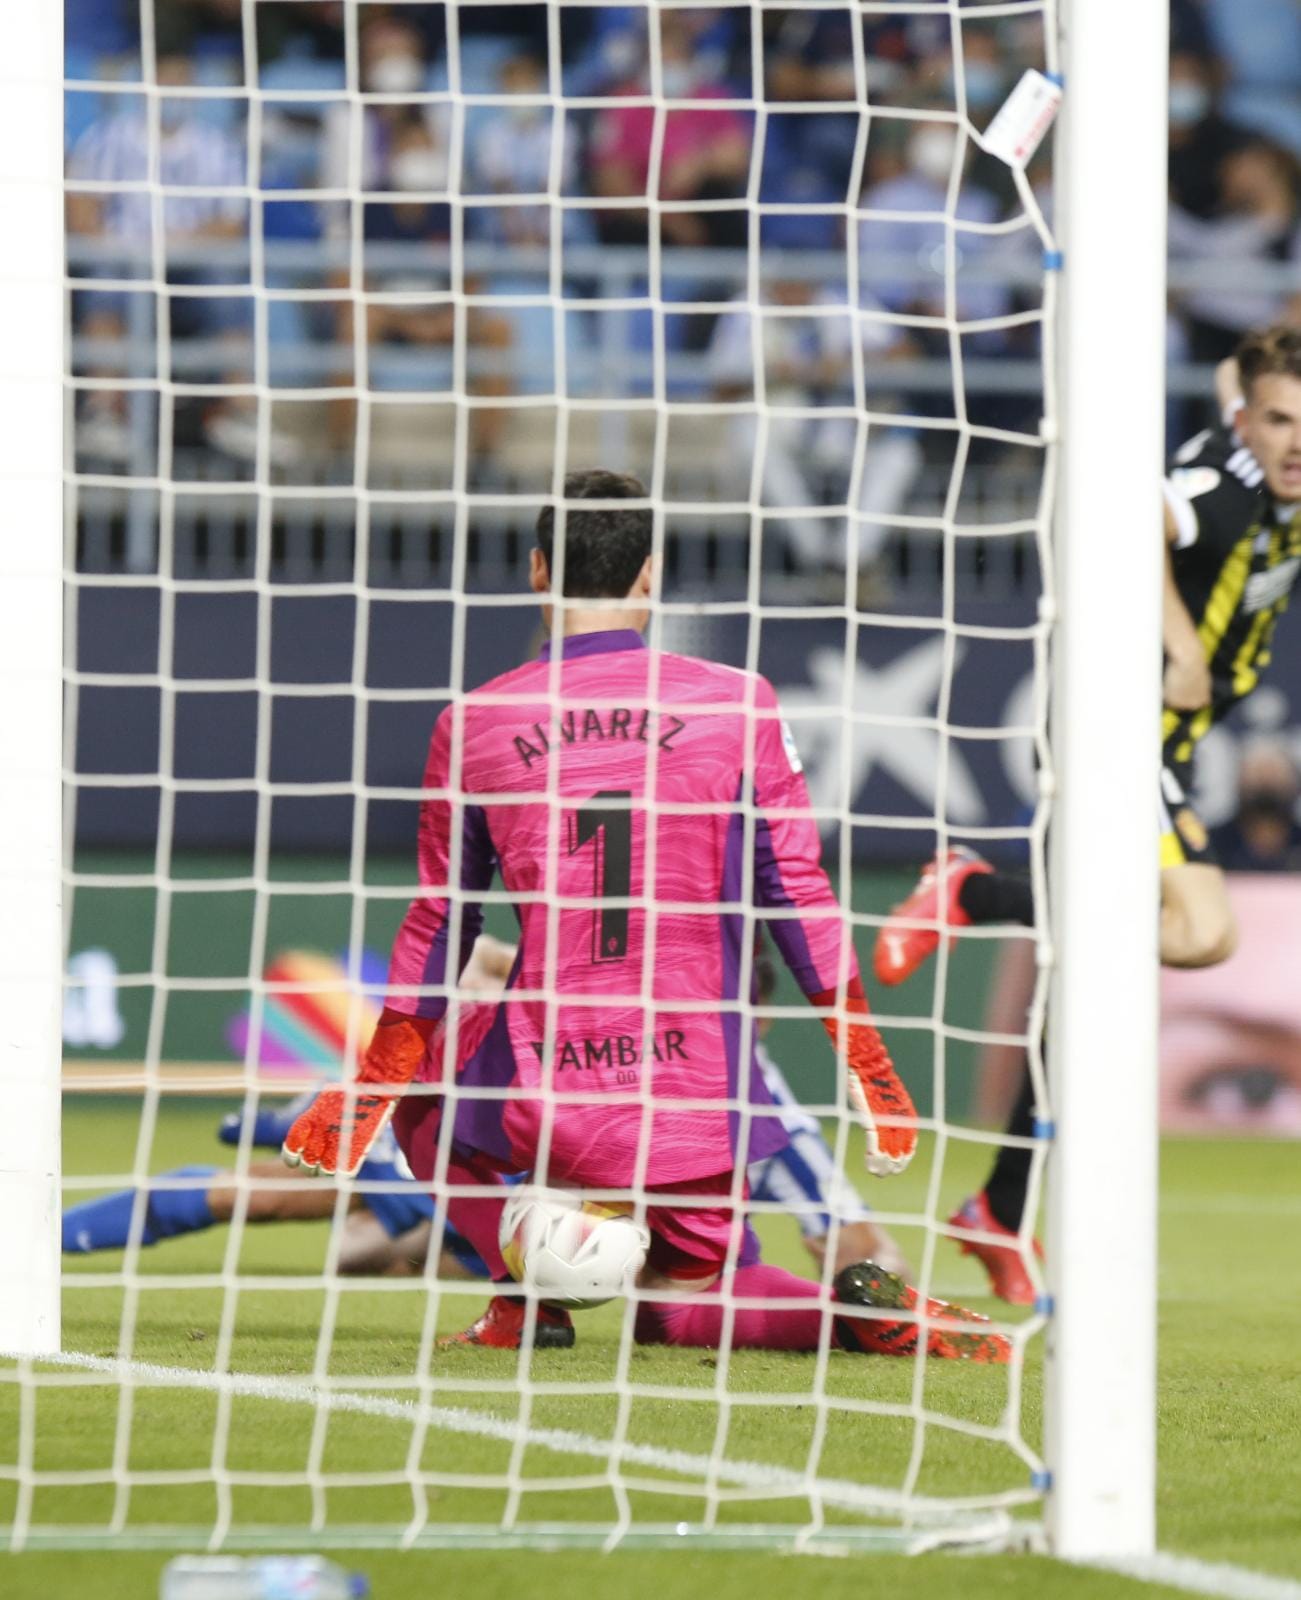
280,1010,434,1178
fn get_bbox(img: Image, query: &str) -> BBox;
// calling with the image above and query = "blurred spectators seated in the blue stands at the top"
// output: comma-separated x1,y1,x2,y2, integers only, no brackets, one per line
66,0,1301,537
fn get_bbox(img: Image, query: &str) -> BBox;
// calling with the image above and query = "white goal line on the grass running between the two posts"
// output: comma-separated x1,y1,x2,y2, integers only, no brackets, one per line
22,1350,1011,1541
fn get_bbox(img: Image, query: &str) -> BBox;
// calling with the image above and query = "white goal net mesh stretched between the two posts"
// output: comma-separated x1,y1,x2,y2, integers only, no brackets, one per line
10,0,1056,1547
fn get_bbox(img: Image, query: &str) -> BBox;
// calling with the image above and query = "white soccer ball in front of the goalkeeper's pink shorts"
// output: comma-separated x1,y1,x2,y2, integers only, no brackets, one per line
499,1189,650,1310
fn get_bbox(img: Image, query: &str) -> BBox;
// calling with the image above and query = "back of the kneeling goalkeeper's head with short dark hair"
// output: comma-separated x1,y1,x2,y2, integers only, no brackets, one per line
538,467,655,600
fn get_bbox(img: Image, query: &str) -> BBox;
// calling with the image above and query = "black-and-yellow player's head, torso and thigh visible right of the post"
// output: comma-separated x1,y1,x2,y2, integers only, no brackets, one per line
1162,326,1301,966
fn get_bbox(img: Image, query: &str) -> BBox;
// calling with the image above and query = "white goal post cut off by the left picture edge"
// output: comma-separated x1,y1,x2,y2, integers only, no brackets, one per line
0,5,64,1355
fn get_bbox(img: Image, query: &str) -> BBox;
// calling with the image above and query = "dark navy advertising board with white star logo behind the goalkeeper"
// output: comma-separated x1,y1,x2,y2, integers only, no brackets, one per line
77,586,1301,861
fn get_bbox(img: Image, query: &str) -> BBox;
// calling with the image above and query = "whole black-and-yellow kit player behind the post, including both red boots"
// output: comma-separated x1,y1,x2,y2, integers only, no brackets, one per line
874,326,1301,1304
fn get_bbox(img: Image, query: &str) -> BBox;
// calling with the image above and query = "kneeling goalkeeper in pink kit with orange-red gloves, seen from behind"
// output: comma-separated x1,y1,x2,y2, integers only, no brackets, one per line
285,470,1008,1360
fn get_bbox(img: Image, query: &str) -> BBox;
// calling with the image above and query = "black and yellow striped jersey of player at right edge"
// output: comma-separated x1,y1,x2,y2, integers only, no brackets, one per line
1163,429,1301,760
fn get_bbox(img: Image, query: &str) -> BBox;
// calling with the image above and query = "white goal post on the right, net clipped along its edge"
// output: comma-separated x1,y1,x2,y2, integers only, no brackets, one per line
1045,0,1170,1557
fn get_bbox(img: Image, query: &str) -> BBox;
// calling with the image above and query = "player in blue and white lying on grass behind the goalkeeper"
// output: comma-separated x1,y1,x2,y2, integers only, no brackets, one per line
62,933,907,1278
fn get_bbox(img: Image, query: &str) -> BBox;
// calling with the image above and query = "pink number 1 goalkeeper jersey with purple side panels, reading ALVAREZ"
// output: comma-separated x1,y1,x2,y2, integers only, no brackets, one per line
380,632,858,1187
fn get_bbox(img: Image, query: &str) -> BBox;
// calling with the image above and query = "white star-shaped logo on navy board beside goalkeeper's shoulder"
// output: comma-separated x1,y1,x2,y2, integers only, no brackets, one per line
781,638,984,832
